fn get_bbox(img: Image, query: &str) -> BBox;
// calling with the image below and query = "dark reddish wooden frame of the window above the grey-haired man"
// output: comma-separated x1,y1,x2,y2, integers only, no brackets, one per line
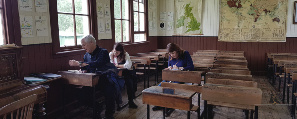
57,0,92,51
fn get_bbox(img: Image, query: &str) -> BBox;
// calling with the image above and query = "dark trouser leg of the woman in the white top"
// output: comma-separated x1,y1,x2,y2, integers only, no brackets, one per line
123,69,137,101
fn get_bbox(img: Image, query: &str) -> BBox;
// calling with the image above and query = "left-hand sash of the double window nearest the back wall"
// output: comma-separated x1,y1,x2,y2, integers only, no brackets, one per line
114,0,130,42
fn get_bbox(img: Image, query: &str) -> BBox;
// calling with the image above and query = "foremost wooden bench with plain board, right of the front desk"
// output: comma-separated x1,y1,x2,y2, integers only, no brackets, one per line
202,83,262,119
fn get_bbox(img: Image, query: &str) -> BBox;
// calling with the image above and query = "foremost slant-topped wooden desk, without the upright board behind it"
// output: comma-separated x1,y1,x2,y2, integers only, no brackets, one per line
142,86,195,119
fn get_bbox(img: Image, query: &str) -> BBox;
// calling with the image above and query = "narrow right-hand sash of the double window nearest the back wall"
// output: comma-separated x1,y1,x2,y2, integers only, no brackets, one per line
133,0,146,42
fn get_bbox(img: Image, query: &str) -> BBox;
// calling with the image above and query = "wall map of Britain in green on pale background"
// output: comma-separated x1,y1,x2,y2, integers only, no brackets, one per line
175,0,202,35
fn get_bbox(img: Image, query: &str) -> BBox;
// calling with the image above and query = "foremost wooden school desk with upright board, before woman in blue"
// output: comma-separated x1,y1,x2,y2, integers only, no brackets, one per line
142,70,203,119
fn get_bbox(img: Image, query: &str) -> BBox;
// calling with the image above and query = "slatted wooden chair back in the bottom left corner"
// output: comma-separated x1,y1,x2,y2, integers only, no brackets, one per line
0,94,37,119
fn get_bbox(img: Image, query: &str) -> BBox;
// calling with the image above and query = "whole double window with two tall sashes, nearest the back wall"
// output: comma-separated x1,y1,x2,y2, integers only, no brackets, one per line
114,0,146,42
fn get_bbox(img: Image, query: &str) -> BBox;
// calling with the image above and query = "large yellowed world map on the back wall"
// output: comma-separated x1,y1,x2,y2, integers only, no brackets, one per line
219,0,288,42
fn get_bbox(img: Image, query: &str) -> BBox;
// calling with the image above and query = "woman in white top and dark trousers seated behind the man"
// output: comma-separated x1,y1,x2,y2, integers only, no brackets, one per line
109,43,137,108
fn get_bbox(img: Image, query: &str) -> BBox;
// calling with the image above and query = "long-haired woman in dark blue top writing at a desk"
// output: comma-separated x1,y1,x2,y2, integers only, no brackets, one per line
153,43,194,116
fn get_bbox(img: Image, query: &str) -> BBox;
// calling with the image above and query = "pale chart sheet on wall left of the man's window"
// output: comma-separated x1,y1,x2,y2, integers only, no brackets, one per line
18,0,52,45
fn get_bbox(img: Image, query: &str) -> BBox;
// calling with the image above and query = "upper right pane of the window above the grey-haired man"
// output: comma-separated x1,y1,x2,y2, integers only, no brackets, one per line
74,0,88,14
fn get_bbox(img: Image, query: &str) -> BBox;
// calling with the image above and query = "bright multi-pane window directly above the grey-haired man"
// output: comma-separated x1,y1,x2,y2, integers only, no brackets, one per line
57,0,90,47
